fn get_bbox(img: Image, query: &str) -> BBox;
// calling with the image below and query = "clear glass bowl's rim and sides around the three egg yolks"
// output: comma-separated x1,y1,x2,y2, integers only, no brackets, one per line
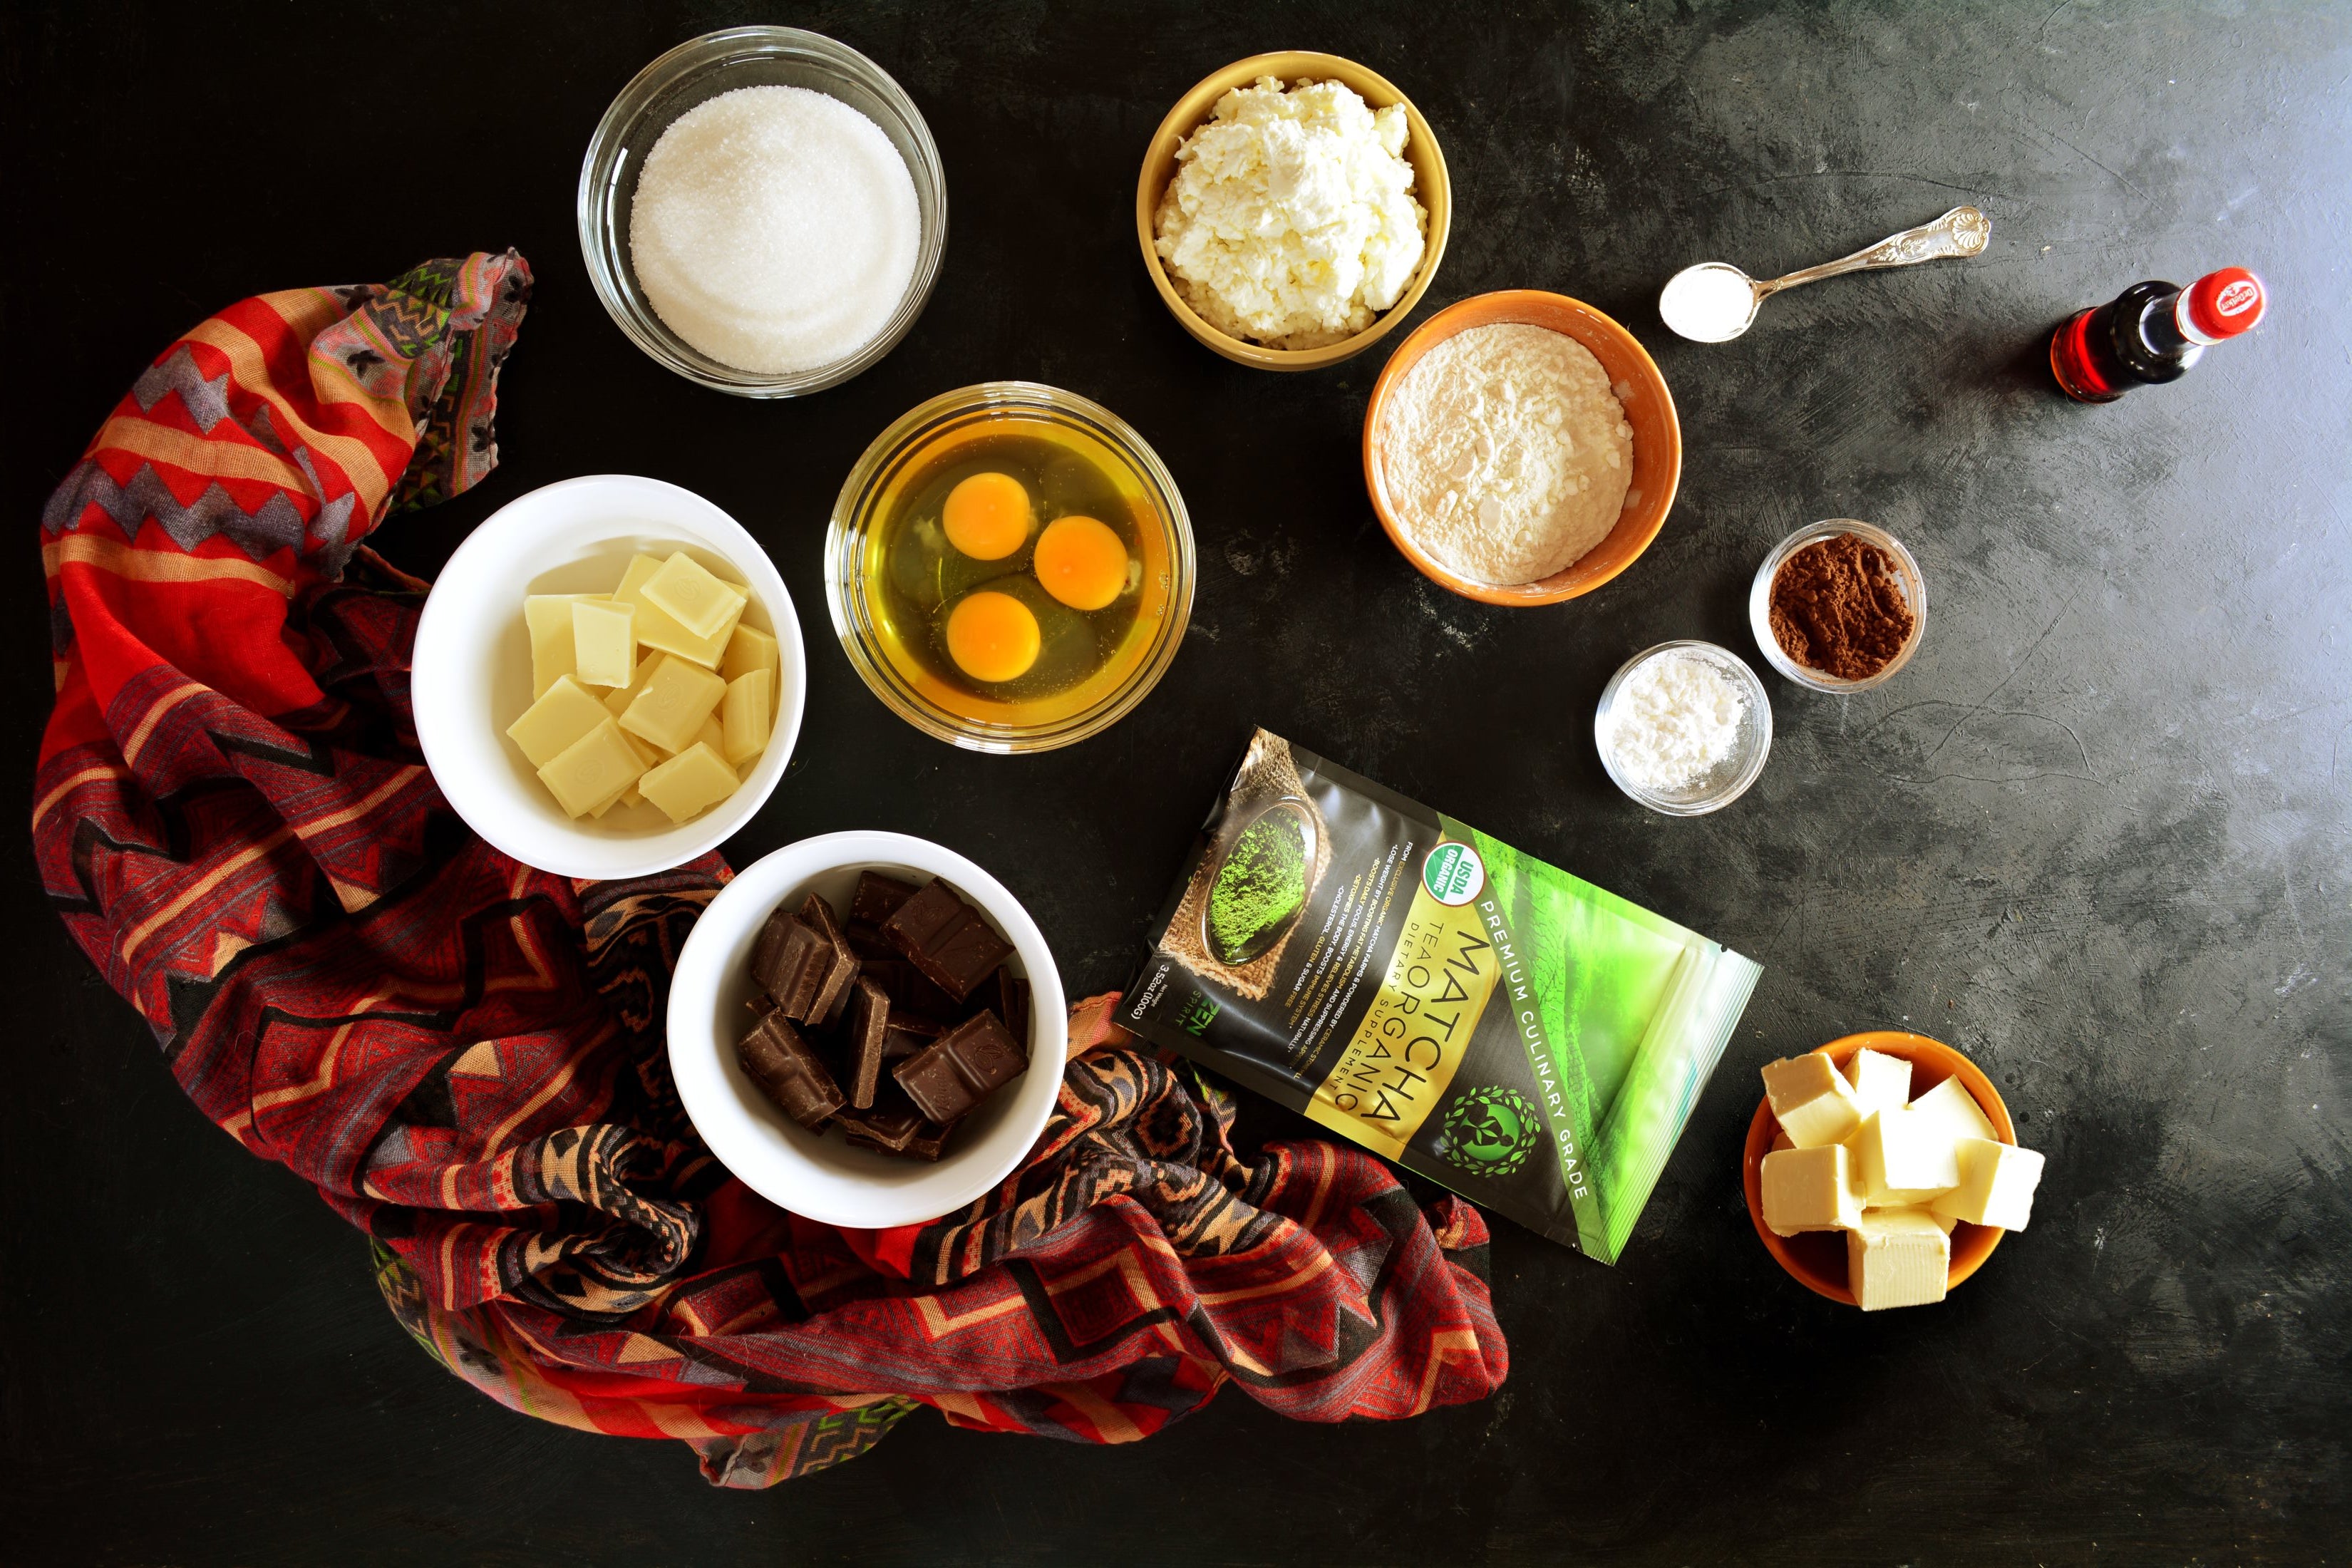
825,381,1195,752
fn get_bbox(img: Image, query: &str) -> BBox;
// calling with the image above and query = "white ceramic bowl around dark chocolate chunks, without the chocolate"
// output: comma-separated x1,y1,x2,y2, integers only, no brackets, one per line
671,832,1071,1229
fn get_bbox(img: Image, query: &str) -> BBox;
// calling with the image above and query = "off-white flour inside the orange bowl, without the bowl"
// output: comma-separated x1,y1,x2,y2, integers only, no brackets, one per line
1381,322,1632,583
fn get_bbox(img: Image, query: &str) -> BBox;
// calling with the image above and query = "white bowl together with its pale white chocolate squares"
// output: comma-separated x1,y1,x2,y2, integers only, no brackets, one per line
409,475,807,880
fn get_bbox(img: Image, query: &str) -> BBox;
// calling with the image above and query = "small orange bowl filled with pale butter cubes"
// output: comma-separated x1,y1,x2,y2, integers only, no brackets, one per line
1743,1030,2041,1311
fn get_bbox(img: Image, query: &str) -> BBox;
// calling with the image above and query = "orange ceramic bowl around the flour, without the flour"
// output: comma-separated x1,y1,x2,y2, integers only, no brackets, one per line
1364,289,1682,607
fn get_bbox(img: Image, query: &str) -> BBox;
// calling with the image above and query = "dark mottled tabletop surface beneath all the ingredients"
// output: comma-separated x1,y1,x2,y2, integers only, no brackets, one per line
0,0,2352,1563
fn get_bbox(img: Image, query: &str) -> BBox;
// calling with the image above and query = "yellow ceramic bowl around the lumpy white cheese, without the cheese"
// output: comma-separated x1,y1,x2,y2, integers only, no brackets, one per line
1136,49,1453,369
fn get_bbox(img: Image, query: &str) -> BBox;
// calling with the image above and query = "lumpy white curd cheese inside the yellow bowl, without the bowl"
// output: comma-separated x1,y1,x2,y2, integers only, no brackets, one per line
1152,76,1428,348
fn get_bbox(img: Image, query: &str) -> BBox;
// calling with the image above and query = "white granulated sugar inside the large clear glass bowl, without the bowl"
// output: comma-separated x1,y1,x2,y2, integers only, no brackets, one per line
628,87,922,376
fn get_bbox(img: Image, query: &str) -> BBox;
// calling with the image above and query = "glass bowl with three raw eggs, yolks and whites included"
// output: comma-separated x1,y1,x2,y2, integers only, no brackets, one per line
825,381,1192,752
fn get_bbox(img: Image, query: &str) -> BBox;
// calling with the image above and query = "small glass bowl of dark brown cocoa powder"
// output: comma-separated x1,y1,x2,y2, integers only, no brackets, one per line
1748,517,1927,693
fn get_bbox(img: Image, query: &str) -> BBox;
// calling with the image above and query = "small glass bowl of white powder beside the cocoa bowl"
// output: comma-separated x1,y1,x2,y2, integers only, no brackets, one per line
1592,639,1771,816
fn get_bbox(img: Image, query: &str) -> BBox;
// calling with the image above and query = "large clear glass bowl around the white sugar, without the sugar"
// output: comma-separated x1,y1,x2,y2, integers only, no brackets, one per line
579,29,948,397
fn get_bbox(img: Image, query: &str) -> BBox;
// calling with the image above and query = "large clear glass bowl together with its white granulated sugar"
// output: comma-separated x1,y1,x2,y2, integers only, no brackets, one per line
579,26,948,397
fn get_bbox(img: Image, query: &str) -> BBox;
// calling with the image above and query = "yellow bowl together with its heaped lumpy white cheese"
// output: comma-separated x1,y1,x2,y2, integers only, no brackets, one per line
1136,49,1453,371
